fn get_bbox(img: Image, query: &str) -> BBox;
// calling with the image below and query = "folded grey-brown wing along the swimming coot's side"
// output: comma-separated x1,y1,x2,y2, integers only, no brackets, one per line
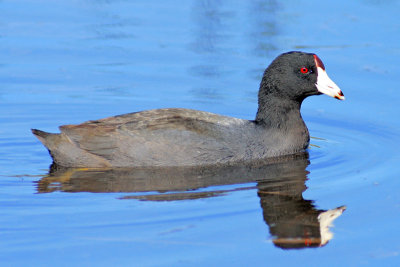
60,109,250,166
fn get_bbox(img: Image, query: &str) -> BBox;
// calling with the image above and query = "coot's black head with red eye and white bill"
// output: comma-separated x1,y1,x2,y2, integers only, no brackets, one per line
259,52,344,104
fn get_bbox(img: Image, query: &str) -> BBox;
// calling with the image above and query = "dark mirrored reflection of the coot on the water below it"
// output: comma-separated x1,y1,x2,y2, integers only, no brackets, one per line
37,153,345,249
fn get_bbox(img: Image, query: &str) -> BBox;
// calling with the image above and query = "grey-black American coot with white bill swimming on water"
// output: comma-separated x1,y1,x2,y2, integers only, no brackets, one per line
32,52,344,167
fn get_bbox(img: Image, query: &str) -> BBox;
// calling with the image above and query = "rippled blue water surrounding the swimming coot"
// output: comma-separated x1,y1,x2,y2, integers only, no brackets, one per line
0,0,400,266
